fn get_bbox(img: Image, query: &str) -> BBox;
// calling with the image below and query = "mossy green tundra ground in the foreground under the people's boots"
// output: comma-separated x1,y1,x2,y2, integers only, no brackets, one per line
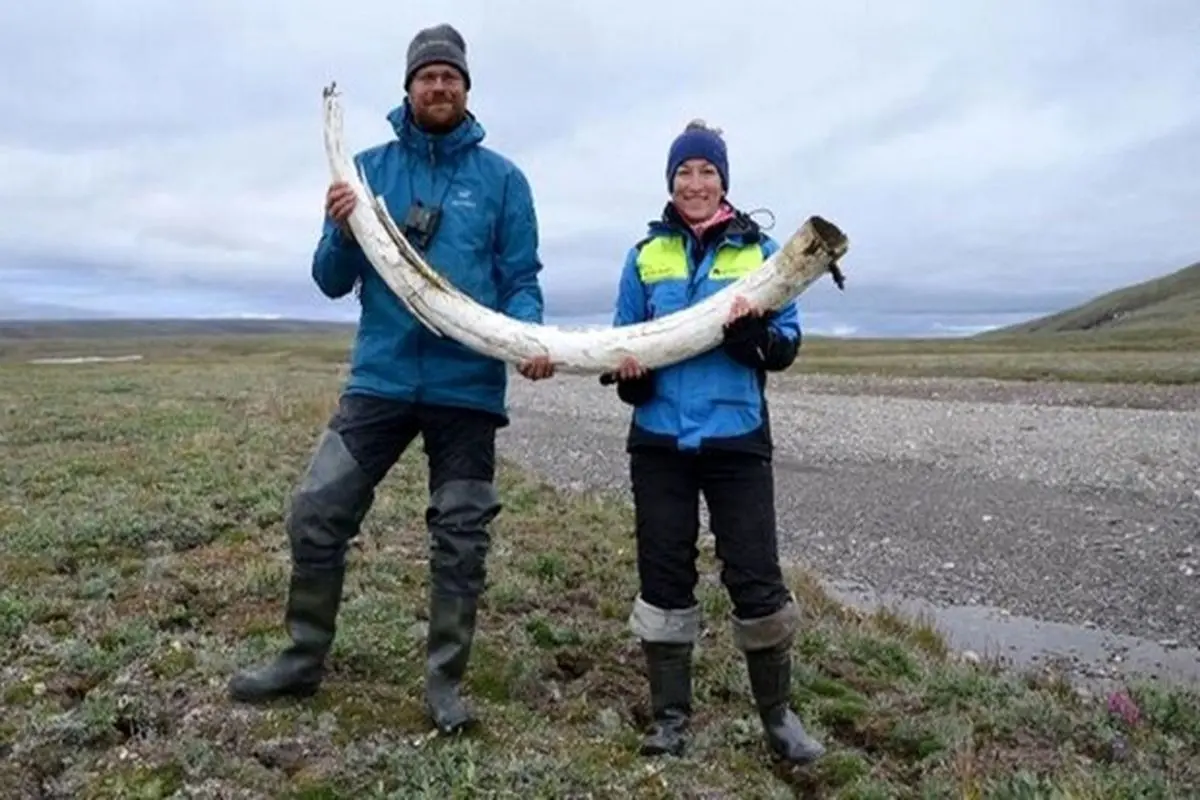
0,344,1200,800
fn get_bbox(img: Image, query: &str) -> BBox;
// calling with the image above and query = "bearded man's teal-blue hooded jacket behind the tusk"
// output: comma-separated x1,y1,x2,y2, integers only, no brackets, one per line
312,100,542,423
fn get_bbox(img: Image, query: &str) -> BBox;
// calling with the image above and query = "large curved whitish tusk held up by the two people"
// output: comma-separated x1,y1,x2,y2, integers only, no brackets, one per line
323,84,850,374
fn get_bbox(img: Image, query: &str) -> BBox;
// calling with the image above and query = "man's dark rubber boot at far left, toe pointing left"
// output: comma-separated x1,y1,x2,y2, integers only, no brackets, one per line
229,569,344,703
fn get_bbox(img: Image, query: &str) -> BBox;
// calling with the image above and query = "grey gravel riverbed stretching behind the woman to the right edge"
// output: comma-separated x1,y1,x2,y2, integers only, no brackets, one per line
500,377,1200,645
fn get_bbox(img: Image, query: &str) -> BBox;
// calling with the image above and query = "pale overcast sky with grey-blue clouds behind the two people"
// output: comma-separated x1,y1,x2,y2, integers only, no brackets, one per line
0,0,1200,333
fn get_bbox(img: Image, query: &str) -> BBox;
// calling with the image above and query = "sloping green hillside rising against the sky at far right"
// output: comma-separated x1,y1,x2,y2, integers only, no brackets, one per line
979,263,1200,338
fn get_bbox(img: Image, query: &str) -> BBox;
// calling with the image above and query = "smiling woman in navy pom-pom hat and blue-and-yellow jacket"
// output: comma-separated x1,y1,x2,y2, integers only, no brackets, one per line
600,120,824,764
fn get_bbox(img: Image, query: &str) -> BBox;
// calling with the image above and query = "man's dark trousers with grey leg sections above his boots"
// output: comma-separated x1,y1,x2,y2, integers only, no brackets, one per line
287,395,500,596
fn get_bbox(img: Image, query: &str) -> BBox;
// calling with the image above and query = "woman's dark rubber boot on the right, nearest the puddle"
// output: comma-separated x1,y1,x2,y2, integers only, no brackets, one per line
745,642,826,765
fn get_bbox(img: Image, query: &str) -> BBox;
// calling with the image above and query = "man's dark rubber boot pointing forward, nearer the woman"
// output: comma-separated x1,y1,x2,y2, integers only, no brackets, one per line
425,594,478,734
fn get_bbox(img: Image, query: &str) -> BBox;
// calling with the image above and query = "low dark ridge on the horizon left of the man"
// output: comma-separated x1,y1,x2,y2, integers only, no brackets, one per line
0,318,354,342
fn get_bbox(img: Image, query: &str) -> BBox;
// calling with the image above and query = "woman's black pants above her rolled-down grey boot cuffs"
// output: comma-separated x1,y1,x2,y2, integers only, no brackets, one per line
630,449,791,620
